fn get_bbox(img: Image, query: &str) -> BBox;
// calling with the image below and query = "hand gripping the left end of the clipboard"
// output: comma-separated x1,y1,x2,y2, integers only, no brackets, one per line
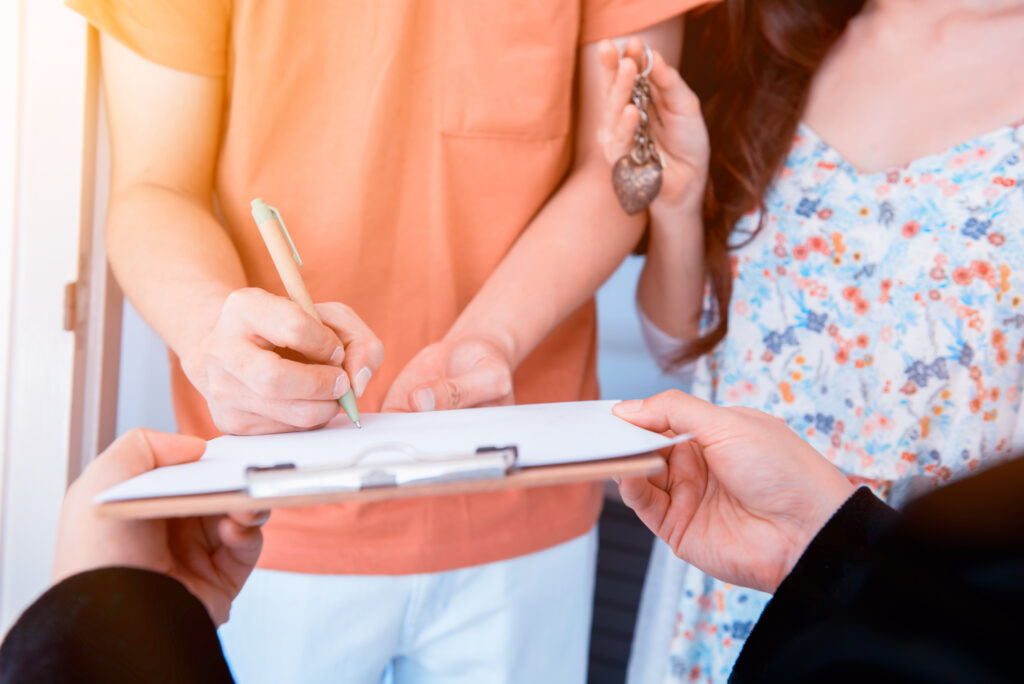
52,430,269,625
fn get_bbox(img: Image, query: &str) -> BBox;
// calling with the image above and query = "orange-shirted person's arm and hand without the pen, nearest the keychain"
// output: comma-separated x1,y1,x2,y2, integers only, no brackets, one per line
384,17,683,411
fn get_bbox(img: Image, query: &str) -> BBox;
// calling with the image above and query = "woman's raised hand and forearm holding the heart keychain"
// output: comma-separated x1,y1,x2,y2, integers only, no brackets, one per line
598,40,710,340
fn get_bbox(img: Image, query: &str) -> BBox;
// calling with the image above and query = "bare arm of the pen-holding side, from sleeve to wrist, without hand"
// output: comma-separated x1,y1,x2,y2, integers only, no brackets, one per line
100,34,235,374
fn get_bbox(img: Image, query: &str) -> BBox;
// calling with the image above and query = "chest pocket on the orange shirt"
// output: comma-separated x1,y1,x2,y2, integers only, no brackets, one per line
437,0,580,140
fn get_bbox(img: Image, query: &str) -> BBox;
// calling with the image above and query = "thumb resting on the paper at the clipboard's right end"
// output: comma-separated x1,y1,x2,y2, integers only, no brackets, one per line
612,389,731,443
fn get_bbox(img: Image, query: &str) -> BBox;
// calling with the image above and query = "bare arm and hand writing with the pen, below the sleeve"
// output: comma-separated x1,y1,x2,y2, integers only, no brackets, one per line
101,35,383,434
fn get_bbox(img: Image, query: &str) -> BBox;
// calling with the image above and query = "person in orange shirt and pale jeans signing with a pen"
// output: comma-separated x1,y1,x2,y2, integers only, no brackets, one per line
68,0,696,682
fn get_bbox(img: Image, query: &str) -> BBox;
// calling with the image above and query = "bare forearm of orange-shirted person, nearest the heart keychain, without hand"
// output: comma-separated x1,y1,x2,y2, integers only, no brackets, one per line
449,163,644,367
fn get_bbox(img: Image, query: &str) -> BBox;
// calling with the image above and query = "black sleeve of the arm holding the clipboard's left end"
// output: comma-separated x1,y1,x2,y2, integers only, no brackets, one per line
0,567,233,684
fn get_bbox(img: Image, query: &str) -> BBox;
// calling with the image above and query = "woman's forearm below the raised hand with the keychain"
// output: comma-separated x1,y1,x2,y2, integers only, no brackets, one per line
637,201,707,340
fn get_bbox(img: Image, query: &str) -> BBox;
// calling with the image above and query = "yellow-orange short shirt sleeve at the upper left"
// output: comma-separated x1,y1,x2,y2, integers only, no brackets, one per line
66,0,231,76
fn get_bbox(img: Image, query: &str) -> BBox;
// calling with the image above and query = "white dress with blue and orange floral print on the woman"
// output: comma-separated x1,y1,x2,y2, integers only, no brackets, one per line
640,122,1024,682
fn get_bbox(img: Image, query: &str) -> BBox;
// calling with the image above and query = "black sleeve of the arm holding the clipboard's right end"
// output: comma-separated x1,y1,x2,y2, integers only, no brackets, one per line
730,460,1024,684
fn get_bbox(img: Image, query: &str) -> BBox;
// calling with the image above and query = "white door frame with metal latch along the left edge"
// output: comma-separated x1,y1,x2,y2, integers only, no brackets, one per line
0,0,120,634
